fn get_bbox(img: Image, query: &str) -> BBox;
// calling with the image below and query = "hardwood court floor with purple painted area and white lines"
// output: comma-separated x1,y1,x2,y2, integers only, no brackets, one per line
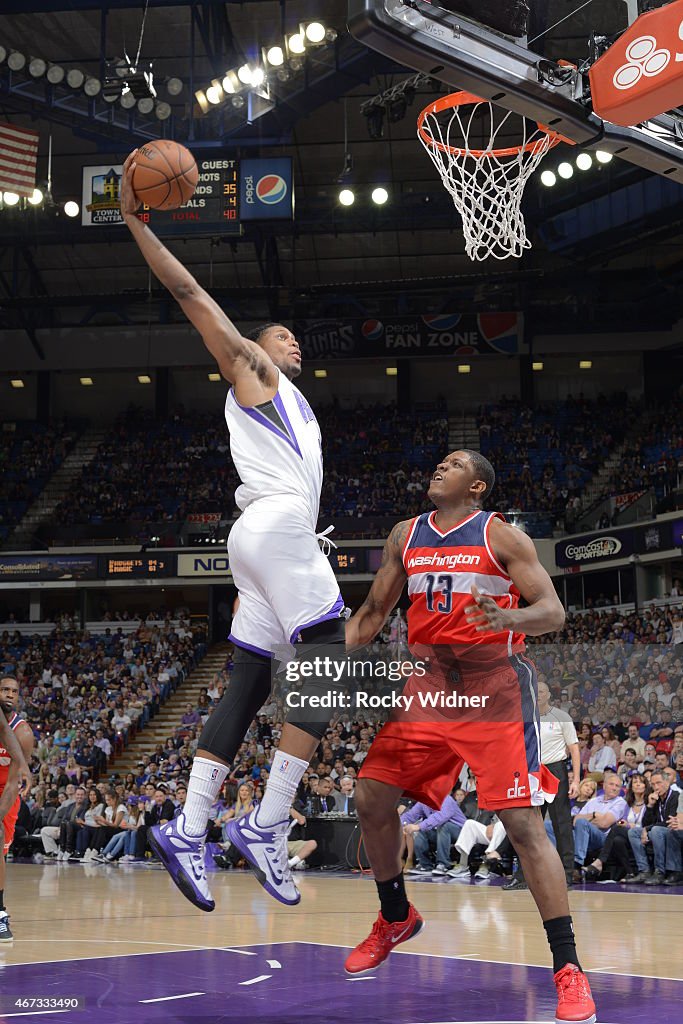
0,864,683,1024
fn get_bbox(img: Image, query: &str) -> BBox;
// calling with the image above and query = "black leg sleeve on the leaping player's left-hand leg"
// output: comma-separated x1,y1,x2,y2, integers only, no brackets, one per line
199,647,271,764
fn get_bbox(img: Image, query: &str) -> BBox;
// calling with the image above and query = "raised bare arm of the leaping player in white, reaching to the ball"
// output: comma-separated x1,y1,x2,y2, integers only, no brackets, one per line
121,151,278,391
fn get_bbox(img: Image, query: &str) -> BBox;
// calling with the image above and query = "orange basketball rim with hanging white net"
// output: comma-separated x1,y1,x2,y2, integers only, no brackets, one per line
418,92,569,260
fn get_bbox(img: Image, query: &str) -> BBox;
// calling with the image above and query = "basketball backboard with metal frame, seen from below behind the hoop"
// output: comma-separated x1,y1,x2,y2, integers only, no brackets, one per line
349,0,683,183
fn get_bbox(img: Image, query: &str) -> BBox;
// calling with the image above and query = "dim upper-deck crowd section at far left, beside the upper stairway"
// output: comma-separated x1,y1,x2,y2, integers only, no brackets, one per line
0,420,81,541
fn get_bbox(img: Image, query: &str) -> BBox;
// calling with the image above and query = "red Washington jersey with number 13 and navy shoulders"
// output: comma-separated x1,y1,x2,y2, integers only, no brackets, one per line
402,510,524,671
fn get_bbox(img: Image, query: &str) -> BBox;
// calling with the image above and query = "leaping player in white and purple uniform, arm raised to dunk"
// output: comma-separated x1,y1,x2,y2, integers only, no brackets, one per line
121,153,345,910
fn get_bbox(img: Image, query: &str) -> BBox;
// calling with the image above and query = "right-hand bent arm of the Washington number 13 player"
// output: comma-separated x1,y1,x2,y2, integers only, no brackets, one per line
465,519,564,637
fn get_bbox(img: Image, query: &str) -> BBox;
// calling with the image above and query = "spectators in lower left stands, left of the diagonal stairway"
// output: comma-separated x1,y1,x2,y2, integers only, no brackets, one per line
0,611,206,860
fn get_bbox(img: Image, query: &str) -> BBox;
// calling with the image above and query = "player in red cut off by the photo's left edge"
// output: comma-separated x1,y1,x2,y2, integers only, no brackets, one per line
0,676,34,942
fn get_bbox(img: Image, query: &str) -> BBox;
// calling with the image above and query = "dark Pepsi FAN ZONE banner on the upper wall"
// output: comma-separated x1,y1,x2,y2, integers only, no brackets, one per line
294,312,527,359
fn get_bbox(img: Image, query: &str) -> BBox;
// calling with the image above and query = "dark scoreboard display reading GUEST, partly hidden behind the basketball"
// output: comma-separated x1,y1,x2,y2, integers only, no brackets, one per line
137,157,242,238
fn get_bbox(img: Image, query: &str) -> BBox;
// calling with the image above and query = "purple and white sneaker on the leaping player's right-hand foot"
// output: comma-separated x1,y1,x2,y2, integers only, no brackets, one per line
225,808,301,906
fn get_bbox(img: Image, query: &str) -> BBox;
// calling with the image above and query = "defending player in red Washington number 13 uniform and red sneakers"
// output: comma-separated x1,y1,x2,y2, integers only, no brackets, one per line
346,451,595,1024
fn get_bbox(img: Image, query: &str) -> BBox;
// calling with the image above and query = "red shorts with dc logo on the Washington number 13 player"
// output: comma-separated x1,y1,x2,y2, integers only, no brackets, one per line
358,654,558,811
